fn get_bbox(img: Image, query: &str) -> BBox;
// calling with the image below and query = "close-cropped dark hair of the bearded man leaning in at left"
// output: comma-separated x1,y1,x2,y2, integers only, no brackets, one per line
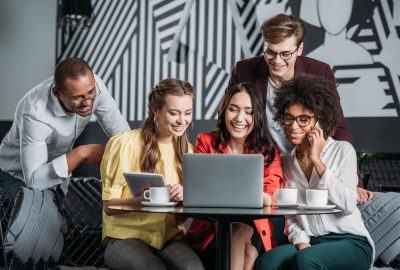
54,57,93,89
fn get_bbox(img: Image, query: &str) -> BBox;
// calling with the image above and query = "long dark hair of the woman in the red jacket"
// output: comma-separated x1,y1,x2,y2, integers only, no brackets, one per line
215,82,275,165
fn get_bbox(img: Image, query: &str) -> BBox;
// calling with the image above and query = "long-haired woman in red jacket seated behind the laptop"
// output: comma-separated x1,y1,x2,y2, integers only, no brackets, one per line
186,83,282,270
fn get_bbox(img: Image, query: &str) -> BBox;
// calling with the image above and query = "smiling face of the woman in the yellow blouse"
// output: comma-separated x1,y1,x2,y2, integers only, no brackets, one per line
154,95,193,143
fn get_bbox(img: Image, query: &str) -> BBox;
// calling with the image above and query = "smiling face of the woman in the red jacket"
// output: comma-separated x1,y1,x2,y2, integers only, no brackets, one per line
225,91,254,142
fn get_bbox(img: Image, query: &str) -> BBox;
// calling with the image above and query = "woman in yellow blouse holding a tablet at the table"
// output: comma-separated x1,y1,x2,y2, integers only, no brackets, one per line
100,79,204,270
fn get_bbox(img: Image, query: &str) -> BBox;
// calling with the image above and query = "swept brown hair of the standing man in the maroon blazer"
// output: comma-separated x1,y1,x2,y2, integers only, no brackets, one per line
260,14,306,46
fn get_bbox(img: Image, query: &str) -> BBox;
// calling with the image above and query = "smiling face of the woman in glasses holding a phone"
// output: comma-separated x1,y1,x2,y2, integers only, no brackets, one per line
283,103,316,145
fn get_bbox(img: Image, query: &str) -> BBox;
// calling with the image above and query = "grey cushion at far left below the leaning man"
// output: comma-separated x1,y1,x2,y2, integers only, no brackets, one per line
4,187,65,264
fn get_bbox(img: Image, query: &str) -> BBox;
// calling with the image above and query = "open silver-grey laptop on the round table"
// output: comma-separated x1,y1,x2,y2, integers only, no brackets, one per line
183,154,264,208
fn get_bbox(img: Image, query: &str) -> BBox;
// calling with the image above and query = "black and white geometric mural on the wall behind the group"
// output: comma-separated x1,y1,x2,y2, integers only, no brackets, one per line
56,0,400,152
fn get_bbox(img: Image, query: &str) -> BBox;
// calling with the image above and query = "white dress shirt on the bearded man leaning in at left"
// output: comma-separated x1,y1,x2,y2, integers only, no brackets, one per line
0,75,130,192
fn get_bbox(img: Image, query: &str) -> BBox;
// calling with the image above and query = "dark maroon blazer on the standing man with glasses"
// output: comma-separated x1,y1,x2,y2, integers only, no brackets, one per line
228,56,363,187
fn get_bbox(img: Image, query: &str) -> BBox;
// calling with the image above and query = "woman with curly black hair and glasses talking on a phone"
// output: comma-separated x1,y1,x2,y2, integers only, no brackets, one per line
257,75,374,270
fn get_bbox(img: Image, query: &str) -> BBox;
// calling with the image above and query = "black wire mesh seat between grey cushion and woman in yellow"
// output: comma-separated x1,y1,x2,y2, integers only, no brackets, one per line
59,177,104,267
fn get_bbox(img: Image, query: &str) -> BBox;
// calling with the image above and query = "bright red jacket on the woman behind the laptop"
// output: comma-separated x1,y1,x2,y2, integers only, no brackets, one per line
186,131,283,250
